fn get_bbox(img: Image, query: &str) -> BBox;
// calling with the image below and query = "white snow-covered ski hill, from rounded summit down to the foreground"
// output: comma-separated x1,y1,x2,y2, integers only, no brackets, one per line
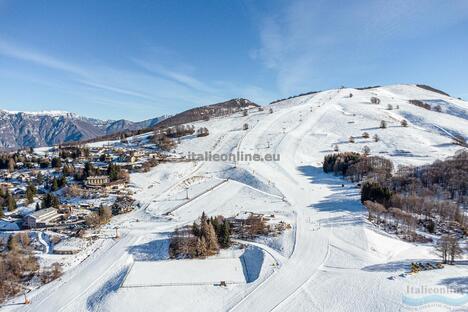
2,85,468,312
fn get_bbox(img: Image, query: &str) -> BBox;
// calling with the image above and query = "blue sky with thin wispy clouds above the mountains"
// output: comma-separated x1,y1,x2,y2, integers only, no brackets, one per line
0,0,468,120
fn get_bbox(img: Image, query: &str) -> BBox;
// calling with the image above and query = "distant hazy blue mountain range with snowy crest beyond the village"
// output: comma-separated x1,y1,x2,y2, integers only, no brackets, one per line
0,110,166,149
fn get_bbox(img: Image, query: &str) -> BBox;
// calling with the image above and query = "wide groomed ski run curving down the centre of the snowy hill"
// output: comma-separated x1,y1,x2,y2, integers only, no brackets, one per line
231,91,336,311
